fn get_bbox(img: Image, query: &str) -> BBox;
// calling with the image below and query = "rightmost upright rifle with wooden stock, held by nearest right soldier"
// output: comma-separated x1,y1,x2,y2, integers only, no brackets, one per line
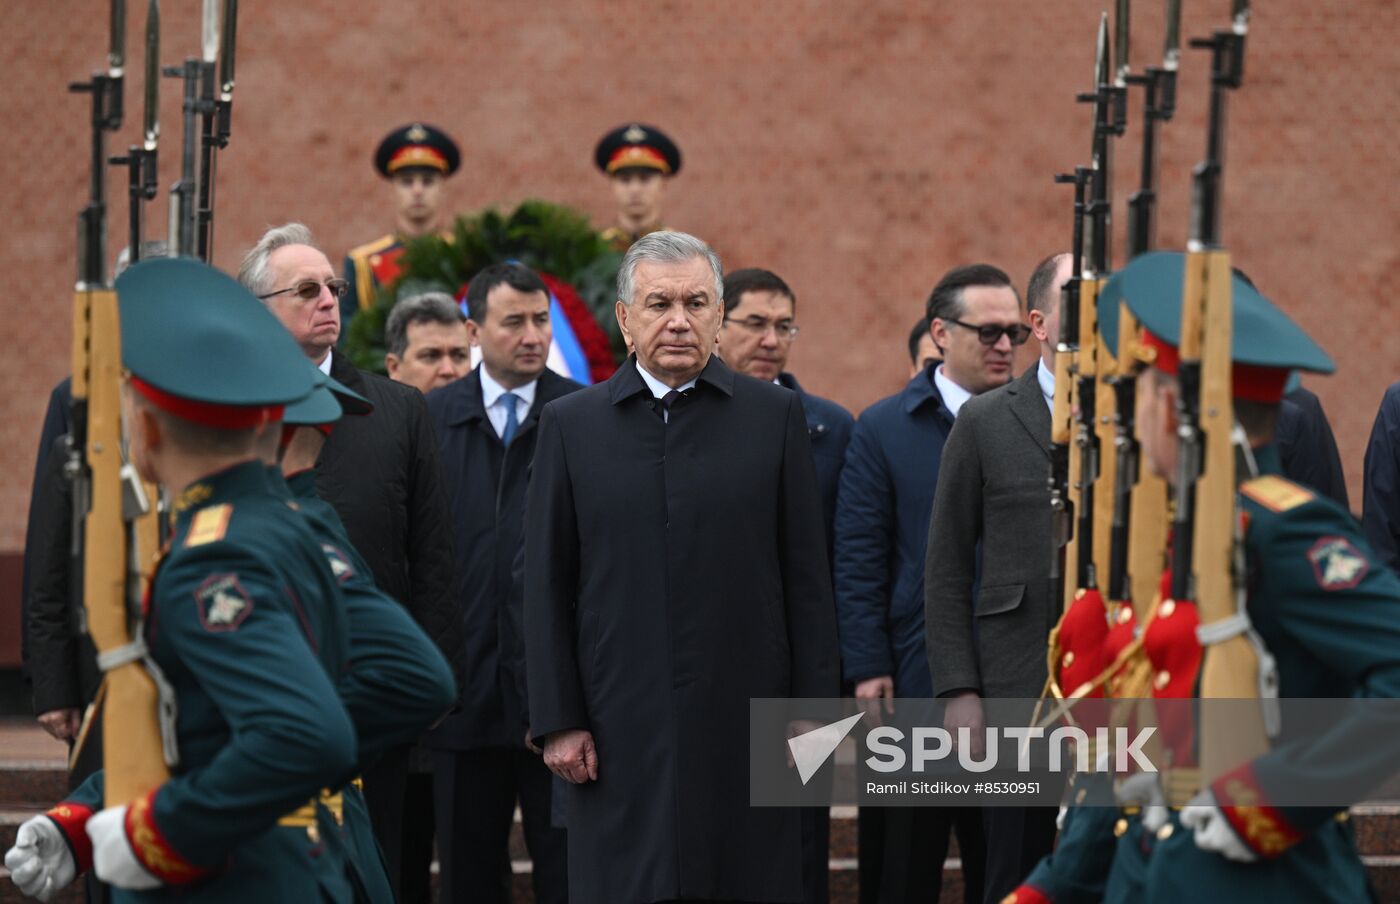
1172,0,1268,784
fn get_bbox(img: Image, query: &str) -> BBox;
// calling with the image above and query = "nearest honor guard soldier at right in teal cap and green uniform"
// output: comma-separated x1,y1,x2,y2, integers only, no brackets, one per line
1008,252,1400,904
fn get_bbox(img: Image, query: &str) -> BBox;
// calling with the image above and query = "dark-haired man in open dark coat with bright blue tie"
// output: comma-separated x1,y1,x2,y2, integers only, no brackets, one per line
427,263,581,904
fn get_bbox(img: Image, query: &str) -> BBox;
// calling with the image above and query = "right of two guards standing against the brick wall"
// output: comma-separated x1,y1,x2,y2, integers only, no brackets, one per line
594,123,680,250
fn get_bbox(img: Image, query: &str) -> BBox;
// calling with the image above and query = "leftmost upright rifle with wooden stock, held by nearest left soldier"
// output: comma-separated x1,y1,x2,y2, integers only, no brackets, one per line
64,0,167,805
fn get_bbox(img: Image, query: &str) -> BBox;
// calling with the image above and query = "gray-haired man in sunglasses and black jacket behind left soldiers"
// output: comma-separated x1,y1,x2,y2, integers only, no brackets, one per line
238,223,462,901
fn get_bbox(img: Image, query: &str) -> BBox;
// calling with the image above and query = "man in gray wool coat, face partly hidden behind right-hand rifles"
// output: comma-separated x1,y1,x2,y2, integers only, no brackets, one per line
924,255,1071,901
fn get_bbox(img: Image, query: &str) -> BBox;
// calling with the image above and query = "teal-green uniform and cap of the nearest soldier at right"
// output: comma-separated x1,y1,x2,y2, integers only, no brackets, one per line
1008,252,1400,904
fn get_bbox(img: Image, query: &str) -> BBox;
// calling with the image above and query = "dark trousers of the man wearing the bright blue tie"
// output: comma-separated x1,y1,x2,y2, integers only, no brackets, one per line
433,749,568,904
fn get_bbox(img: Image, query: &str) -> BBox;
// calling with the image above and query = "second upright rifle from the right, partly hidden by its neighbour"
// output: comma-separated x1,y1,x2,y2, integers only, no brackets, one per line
1105,0,1182,623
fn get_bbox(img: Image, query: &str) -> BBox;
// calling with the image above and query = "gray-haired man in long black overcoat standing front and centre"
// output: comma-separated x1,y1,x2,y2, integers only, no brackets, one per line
525,232,839,904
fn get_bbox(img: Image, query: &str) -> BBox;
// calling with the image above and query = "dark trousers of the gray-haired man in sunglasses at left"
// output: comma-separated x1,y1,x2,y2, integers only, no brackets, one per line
364,747,433,904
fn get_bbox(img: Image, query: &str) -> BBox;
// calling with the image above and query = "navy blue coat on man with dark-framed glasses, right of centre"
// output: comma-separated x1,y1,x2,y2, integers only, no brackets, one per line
834,365,953,697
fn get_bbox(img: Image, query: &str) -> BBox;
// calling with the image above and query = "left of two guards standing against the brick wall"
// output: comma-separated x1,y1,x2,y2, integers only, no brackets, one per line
340,122,462,328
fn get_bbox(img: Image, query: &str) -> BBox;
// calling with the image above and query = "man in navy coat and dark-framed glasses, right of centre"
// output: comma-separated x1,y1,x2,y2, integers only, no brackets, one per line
836,264,1030,901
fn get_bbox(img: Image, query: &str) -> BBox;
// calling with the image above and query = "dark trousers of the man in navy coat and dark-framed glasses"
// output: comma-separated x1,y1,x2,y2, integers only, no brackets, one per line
860,806,1000,904
